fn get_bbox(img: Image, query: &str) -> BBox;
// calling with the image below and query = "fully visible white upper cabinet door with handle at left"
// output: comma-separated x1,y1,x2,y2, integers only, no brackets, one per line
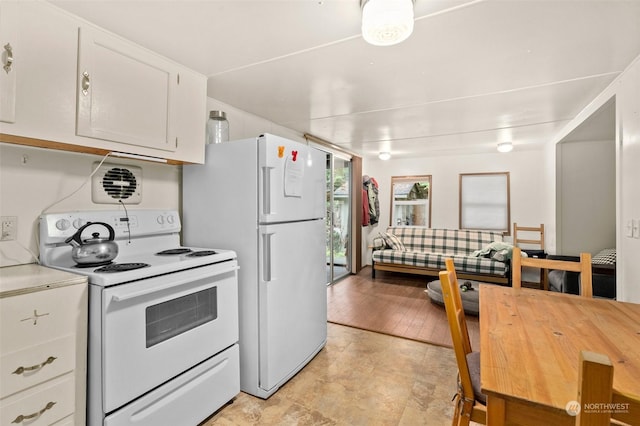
76,27,178,151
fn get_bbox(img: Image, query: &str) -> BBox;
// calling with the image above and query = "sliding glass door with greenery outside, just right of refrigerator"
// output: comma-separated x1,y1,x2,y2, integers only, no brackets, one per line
326,152,351,285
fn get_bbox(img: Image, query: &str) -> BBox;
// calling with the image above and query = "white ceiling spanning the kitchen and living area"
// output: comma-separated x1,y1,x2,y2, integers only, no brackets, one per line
50,0,640,158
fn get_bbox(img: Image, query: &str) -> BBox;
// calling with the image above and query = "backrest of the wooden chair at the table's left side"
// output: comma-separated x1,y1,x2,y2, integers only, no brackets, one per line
439,259,475,401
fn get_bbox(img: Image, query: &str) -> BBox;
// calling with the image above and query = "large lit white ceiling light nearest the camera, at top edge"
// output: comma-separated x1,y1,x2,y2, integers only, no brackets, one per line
360,0,415,46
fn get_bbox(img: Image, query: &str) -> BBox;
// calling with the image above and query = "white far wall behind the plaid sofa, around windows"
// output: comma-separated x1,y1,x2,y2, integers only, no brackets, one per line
362,148,555,264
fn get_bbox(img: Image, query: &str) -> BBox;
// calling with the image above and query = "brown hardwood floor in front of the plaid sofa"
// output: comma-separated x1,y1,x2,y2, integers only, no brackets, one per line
327,266,480,349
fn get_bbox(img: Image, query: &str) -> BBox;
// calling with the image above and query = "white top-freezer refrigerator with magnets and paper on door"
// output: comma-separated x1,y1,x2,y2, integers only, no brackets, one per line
182,134,327,398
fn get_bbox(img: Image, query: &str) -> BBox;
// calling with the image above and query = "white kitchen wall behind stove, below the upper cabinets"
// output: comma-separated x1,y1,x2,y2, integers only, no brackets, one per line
0,143,181,266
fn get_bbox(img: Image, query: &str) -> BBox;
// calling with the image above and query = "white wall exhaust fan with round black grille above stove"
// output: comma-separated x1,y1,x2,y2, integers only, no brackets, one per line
91,163,142,204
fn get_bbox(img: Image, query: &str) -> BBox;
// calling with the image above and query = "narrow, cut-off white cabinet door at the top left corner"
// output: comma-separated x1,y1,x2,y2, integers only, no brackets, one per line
0,2,19,123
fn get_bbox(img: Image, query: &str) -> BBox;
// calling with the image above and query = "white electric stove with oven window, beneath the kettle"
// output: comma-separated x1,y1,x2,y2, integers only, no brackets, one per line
40,209,240,426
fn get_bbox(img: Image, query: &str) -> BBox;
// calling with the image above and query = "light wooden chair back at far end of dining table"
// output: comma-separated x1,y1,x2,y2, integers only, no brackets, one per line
511,247,593,297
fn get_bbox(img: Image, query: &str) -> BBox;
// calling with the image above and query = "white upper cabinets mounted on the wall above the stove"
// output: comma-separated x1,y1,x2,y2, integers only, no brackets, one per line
0,1,207,163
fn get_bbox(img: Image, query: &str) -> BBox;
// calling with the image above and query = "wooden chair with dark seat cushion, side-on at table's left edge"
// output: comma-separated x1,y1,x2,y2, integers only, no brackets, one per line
439,259,487,426
